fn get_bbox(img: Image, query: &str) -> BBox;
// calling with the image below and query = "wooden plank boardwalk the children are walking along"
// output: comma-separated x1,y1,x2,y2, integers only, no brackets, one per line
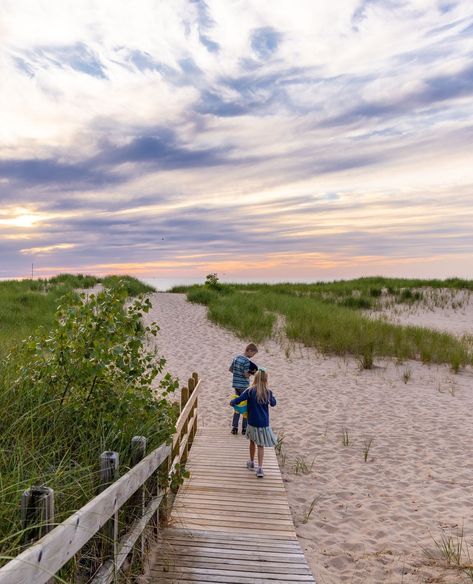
148,428,315,584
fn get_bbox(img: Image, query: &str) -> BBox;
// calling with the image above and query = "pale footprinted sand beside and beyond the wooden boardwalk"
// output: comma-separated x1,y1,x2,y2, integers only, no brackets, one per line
143,293,473,584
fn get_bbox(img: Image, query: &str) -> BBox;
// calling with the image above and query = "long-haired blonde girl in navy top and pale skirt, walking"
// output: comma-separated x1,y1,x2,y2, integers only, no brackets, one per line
230,367,277,478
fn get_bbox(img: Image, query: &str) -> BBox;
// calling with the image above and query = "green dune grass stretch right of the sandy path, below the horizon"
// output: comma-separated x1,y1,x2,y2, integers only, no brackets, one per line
173,278,473,371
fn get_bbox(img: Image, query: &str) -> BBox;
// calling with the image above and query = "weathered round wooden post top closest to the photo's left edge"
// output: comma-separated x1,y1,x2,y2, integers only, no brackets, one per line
21,487,55,584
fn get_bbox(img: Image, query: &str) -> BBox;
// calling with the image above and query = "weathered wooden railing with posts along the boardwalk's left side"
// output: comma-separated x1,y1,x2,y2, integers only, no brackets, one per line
0,373,200,584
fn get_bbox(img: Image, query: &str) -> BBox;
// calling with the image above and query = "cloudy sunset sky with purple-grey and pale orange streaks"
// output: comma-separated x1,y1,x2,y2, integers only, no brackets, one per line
0,0,473,281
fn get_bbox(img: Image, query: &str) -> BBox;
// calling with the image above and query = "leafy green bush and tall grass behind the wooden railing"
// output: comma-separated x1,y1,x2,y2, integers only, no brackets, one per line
0,287,177,556
